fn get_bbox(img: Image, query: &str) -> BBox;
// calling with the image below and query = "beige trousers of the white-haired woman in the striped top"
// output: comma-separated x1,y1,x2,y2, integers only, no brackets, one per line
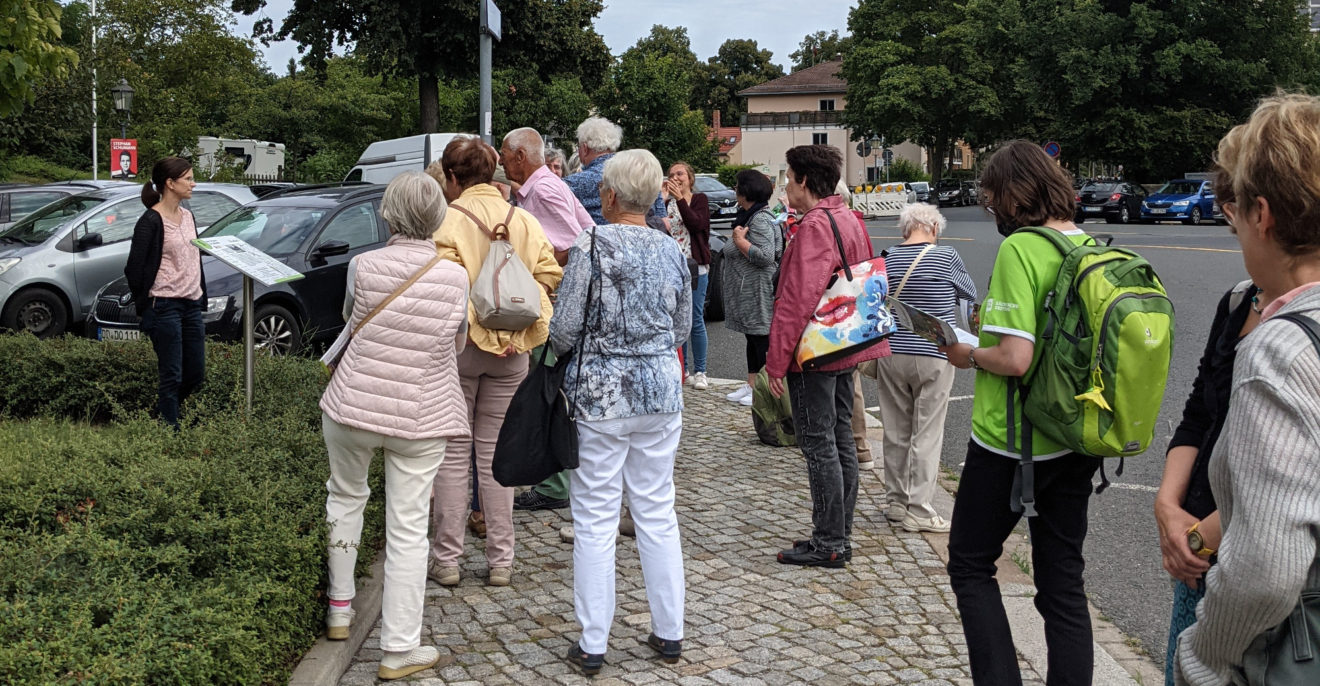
876,355,953,517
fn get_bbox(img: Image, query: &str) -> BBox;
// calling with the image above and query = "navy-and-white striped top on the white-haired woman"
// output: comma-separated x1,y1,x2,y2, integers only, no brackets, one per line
884,243,977,360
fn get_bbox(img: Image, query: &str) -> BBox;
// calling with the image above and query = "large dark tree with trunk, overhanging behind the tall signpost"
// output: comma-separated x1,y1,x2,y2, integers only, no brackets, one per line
232,0,610,132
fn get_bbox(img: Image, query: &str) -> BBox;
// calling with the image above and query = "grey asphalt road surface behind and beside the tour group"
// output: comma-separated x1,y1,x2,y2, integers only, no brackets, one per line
708,201,1246,665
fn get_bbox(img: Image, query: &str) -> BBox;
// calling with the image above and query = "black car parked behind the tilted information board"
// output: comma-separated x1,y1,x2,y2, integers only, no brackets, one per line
87,185,389,355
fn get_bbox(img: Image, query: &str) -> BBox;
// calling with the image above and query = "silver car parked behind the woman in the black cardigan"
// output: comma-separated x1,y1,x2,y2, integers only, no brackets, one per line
0,183,256,338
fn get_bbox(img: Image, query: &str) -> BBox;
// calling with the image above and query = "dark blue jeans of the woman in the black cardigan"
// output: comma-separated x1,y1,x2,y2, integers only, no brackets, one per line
139,298,206,429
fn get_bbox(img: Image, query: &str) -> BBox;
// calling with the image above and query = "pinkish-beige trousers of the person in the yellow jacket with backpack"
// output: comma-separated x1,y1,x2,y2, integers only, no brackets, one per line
430,344,528,569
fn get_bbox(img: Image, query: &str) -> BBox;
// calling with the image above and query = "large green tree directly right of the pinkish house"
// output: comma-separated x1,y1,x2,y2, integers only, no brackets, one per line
842,0,1002,181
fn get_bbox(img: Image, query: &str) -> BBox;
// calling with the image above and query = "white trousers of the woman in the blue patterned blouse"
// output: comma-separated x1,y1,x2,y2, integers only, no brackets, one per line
569,413,685,654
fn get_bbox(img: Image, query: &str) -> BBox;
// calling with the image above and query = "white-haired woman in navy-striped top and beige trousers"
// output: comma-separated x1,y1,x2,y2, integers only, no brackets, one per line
876,204,977,533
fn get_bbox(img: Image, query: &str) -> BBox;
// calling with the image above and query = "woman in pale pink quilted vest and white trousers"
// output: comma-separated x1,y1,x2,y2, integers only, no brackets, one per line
321,172,469,679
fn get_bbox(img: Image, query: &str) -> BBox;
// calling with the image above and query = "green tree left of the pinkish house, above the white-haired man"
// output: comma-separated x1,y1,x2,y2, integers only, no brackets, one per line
595,50,715,170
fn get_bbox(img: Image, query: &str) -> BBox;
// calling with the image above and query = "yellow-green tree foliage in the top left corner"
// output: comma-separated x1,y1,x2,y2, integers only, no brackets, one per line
0,0,78,117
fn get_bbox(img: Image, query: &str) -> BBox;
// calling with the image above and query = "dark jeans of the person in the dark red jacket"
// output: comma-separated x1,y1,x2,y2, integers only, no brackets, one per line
787,369,857,553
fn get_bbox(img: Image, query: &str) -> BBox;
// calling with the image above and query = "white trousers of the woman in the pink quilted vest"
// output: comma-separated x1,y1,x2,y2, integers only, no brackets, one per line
321,414,447,652
